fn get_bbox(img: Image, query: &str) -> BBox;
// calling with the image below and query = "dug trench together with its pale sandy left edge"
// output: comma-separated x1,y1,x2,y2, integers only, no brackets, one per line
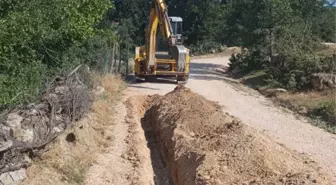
124,96,172,185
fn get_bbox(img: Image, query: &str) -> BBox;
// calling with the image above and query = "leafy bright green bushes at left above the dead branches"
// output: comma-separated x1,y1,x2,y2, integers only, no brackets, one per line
0,0,112,105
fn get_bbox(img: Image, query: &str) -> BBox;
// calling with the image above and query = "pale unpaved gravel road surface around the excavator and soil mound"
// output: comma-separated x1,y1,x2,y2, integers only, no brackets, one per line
128,56,336,184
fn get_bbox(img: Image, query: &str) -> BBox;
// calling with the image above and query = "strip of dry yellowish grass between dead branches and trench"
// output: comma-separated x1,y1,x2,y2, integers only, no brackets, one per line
23,74,126,185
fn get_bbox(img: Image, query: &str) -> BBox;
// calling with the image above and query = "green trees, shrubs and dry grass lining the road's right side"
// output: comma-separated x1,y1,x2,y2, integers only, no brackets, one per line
223,1,336,133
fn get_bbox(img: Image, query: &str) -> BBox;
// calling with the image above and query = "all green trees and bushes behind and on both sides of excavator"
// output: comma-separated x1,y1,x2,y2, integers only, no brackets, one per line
0,0,336,107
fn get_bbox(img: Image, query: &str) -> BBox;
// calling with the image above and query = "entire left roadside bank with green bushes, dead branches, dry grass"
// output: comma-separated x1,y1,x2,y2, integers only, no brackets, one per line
0,0,127,184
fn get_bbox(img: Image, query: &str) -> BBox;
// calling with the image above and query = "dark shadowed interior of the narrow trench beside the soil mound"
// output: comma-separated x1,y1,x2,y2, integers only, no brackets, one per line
141,116,173,185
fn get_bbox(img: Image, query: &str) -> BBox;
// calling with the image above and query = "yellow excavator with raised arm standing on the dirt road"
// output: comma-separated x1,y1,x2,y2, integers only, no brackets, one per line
134,0,190,83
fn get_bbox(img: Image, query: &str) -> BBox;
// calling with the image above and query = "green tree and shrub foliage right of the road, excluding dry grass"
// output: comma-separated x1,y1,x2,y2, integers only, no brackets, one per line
223,0,336,90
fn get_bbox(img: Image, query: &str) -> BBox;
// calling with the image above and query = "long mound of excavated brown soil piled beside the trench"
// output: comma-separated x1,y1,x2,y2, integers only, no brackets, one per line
143,87,331,185
